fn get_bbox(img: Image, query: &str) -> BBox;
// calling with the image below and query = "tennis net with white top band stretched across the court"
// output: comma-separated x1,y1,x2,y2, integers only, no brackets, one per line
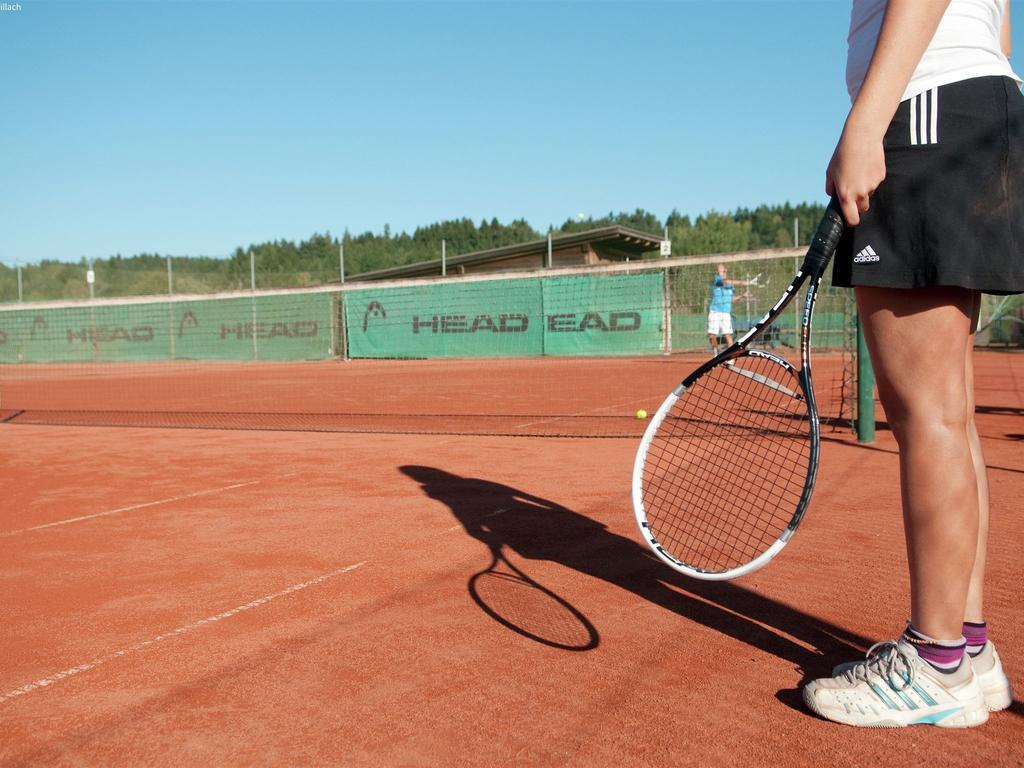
0,252,855,437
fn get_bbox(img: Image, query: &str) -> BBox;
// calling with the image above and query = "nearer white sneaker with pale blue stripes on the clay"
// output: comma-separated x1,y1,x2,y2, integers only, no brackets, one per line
804,639,988,728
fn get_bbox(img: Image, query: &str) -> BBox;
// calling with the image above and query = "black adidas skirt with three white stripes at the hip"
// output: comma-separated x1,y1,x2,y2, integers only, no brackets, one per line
833,77,1024,294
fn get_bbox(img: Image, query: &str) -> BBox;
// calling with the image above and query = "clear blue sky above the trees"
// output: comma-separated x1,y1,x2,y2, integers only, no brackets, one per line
0,0,1024,264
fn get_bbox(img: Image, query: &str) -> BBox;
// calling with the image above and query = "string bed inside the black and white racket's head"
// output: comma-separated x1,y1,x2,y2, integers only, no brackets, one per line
643,355,810,571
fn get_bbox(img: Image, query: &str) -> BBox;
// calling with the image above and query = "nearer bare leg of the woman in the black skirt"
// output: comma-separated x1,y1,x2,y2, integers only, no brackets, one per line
856,288,979,641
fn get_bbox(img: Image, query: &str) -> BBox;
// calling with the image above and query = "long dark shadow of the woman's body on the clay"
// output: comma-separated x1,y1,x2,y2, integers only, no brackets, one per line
399,465,870,684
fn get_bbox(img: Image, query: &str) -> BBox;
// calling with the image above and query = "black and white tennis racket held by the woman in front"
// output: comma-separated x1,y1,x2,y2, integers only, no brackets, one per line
633,199,844,580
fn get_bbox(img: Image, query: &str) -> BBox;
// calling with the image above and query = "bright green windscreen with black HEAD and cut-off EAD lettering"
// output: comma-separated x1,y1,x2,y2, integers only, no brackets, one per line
345,271,665,358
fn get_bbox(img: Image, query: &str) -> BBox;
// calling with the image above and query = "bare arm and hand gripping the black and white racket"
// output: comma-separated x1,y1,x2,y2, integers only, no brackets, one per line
825,0,950,226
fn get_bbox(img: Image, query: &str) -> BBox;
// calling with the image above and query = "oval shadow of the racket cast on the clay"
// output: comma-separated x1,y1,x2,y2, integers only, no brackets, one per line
468,545,600,650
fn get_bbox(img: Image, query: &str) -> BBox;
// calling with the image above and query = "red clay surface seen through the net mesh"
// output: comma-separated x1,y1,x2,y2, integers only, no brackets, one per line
0,348,853,437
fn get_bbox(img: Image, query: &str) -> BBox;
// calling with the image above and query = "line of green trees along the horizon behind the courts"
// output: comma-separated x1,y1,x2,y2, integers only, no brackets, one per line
0,203,824,301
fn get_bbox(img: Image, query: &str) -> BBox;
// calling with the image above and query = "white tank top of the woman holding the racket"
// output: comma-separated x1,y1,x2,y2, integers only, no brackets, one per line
846,0,1021,101
